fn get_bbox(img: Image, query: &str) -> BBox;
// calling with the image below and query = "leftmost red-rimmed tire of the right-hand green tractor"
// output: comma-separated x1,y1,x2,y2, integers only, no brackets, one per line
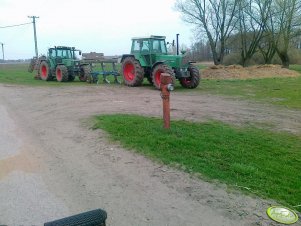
122,57,144,86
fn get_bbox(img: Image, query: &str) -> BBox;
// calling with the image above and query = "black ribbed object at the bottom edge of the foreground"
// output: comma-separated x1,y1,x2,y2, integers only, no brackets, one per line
44,209,107,226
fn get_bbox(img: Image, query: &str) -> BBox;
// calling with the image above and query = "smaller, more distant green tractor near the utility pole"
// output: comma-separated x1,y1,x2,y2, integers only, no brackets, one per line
28,46,91,82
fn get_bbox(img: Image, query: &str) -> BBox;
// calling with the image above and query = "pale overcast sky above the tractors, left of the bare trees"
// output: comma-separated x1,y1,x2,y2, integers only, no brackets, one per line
0,0,194,59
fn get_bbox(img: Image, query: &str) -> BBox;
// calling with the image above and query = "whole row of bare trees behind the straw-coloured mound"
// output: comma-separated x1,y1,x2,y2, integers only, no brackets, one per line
176,0,301,67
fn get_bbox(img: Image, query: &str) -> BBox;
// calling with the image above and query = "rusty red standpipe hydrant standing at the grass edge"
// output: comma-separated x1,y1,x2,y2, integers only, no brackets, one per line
160,73,174,129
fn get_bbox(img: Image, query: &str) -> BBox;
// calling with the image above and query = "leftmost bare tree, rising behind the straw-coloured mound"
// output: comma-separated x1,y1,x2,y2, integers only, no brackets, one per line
176,0,239,65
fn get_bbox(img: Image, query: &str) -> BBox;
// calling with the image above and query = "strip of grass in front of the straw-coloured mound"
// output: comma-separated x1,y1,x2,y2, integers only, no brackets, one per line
192,76,301,109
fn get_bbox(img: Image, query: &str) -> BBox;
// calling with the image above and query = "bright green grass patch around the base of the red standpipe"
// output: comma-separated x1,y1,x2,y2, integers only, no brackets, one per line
93,115,301,210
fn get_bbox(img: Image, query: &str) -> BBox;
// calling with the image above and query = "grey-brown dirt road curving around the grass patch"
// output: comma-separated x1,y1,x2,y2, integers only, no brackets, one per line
0,85,301,226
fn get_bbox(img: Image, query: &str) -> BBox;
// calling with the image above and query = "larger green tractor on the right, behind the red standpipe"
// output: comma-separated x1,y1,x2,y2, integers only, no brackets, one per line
121,35,200,89
